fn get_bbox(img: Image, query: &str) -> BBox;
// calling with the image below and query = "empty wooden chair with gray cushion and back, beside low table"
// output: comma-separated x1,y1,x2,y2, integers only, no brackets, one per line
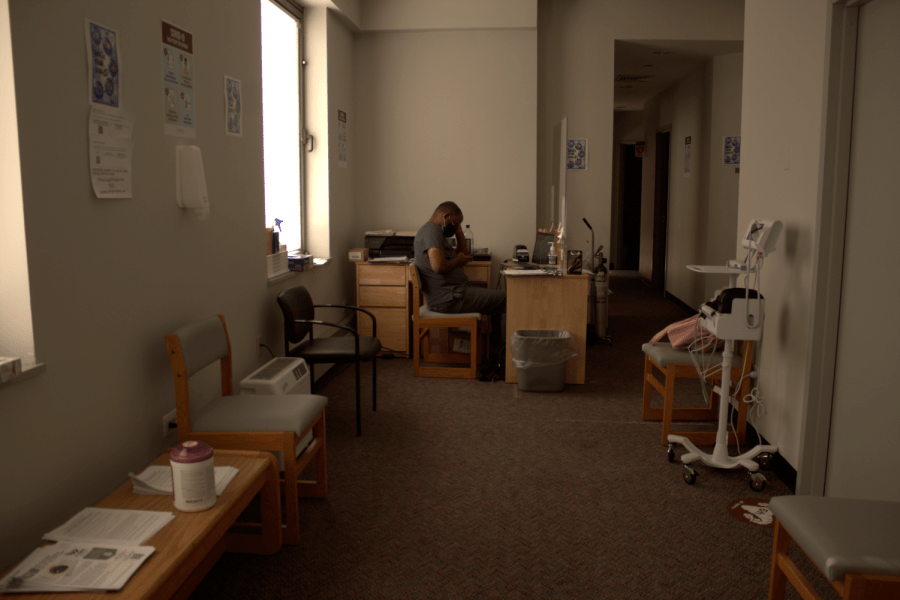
166,315,328,544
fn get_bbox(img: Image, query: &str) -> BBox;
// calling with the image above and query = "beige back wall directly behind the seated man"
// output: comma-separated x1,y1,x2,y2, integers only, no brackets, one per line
352,29,537,282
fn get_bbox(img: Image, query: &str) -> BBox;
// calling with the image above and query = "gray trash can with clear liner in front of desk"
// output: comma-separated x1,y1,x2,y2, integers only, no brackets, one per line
509,329,580,392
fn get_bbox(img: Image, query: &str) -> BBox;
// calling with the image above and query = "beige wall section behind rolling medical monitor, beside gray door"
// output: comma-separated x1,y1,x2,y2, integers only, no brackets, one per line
734,0,829,467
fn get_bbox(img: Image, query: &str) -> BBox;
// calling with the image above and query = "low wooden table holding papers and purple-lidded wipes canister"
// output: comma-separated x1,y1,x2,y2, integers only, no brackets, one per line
9,450,281,600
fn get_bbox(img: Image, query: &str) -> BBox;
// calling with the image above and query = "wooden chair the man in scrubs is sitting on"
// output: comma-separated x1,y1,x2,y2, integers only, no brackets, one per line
409,265,488,379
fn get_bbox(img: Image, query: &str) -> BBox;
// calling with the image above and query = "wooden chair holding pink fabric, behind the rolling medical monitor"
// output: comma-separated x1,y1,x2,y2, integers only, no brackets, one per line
641,341,753,446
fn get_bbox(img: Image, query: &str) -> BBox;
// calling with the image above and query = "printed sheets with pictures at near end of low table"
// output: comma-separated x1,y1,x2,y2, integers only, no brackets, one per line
0,542,155,593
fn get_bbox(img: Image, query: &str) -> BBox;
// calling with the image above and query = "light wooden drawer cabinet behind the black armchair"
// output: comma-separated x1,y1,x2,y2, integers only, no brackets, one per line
356,262,410,356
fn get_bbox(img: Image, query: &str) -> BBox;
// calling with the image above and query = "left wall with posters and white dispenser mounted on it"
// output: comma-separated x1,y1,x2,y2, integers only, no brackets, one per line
0,0,352,568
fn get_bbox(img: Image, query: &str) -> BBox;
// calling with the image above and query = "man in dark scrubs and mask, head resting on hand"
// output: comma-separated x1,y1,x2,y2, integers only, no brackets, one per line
413,202,506,380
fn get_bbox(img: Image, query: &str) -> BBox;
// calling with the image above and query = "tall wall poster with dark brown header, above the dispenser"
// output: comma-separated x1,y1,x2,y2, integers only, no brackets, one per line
161,21,197,138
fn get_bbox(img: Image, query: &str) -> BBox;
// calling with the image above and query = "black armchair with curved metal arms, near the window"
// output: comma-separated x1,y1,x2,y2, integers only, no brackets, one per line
277,286,381,435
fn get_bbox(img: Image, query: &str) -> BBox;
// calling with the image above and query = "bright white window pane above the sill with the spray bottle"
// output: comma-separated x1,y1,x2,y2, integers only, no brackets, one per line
260,0,304,250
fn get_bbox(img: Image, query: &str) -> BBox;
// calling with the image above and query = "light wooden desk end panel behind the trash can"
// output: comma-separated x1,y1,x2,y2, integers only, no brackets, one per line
501,275,590,383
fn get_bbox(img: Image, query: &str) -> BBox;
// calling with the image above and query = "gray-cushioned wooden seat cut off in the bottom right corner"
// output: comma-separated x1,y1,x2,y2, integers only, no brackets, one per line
769,496,900,600
